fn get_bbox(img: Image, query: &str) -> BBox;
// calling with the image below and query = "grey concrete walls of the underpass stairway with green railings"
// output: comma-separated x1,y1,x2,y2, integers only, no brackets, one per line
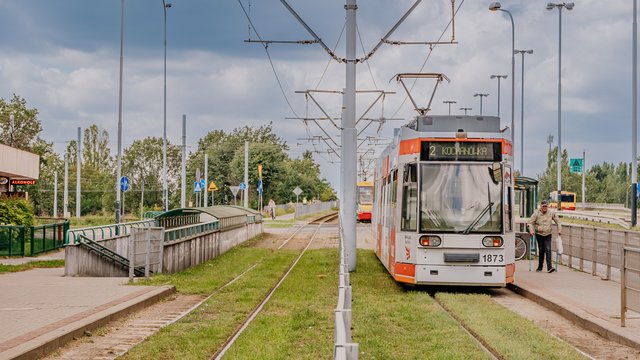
65,223,262,277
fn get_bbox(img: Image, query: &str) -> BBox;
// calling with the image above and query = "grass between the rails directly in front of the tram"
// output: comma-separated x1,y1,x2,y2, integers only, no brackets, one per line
436,293,585,359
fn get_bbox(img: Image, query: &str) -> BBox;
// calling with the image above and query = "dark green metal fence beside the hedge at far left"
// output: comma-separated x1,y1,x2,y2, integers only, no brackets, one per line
0,219,69,256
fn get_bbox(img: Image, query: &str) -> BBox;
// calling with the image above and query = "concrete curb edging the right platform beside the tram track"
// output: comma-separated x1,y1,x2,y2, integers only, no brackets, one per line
507,284,640,350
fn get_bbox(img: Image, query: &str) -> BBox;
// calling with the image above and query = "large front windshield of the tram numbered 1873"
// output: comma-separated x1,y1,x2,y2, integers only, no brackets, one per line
420,164,502,234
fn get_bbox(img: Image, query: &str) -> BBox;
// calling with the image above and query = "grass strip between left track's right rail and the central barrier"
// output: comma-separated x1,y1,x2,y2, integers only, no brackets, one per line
225,249,339,360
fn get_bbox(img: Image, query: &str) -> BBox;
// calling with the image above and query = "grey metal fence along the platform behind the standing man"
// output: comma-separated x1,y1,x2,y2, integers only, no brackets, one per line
551,224,640,280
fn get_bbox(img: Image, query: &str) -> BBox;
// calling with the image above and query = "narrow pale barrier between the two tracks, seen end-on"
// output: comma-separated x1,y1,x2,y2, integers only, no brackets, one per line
333,217,358,360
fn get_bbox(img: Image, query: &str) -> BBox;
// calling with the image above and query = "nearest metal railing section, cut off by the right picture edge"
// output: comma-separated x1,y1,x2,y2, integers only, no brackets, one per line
620,246,640,327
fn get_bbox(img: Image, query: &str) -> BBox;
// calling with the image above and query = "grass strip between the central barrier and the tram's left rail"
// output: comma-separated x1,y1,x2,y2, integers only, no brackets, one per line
351,250,489,359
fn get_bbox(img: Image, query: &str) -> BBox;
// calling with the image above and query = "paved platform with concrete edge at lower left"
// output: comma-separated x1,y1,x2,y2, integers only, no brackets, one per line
0,268,175,360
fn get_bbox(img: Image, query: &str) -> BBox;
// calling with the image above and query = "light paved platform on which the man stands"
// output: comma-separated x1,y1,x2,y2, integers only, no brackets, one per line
510,260,640,349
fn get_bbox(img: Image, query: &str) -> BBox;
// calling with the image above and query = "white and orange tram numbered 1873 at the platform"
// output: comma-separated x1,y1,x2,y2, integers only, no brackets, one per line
372,116,515,287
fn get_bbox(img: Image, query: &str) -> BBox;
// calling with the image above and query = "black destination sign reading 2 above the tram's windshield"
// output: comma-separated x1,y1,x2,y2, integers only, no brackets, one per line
420,141,502,161
